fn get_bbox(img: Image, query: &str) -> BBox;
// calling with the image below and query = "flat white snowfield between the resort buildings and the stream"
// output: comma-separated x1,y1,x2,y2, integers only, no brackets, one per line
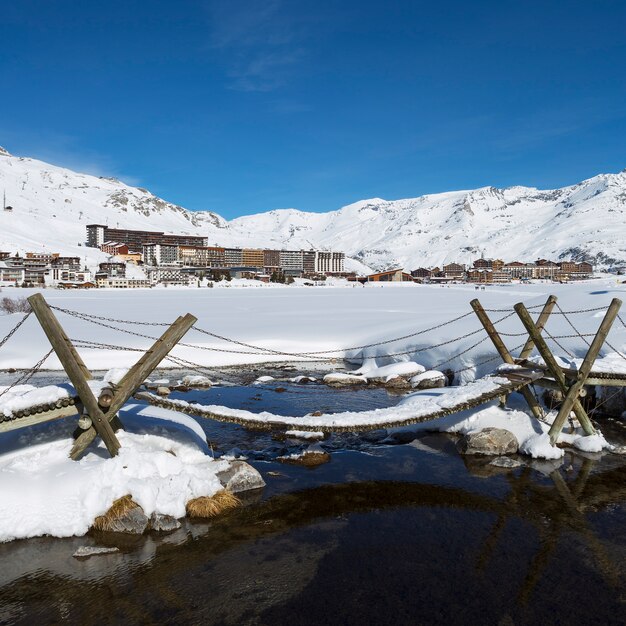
0,278,626,382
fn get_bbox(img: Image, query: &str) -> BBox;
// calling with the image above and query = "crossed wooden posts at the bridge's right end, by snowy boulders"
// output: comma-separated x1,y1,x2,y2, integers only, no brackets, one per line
470,296,622,445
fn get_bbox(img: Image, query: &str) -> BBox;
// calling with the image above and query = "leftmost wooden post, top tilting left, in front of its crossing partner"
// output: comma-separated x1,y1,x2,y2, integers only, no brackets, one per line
28,293,120,456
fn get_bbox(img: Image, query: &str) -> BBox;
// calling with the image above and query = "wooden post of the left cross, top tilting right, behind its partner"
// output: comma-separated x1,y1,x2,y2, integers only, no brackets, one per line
70,313,197,459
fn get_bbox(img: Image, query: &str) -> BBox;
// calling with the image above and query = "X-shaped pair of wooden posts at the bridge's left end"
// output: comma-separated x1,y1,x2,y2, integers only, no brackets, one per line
28,294,197,459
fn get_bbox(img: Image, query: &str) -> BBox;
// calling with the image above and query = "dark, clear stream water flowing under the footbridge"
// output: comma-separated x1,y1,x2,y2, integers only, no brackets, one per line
0,368,626,626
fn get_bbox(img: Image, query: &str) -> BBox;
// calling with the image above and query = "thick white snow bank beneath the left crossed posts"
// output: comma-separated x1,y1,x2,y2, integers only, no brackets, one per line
0,408,228,541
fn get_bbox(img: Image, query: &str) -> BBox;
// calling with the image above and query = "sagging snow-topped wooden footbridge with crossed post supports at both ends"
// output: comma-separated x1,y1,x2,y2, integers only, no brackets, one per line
0,294,626,459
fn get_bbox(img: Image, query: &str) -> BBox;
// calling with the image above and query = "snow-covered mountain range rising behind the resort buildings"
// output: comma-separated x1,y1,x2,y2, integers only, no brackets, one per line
0,148,626,269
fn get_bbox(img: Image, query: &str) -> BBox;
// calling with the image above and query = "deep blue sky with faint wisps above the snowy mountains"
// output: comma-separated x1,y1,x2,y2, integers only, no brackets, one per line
0,0,626,218
